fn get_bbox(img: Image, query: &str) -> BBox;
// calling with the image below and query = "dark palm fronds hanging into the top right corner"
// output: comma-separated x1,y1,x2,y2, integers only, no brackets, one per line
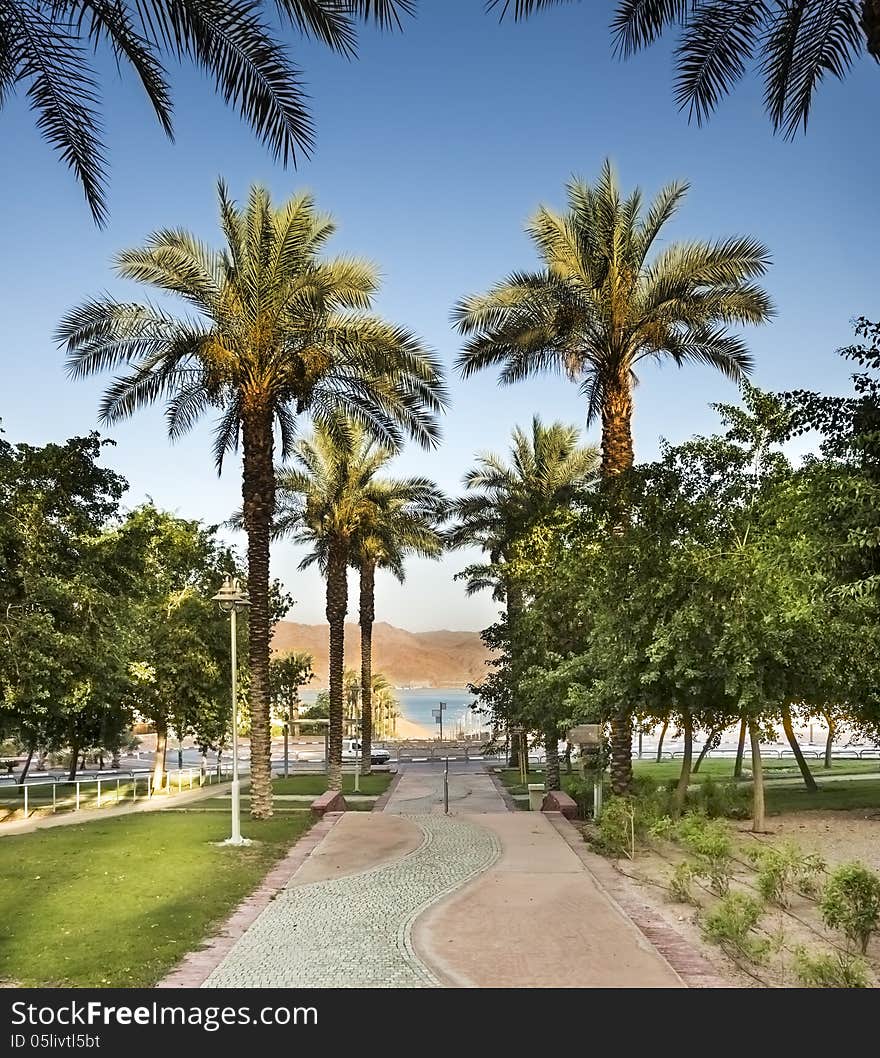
489,0,880,138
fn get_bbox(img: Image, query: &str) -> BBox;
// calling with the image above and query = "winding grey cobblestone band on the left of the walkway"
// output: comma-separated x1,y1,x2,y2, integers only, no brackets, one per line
202,815,500,988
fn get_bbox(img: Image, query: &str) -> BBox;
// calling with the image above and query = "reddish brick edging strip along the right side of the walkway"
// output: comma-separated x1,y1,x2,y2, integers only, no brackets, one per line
545,813,732,988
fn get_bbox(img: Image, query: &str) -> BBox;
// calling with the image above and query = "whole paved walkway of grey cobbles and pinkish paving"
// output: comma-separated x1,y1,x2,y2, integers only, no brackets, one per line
189,765,708,988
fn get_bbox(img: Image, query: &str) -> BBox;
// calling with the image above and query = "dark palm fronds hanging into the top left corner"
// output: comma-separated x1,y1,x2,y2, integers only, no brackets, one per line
0,0,414,224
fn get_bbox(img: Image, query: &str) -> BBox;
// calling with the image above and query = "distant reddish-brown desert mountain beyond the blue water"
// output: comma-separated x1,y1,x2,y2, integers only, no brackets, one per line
272,621,489,687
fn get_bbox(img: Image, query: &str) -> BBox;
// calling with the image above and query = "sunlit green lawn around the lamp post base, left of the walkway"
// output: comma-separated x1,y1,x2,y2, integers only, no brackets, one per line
0,809,313,987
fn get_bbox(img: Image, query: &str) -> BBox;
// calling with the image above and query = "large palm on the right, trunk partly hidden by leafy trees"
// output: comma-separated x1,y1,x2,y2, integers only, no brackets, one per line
454,162,773,791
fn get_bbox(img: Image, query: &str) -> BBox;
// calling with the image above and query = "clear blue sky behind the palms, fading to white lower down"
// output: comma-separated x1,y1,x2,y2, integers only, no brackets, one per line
0,0,880,631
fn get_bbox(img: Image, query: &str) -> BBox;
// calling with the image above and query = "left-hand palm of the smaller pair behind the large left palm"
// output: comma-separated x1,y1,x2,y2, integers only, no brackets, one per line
275,422,440,789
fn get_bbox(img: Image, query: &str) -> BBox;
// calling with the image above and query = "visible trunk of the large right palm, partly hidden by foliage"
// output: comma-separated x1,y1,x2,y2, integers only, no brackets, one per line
600,370,634,795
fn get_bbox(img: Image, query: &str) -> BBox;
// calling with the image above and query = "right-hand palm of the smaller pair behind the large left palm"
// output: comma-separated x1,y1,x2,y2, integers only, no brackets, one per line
352,477,446,774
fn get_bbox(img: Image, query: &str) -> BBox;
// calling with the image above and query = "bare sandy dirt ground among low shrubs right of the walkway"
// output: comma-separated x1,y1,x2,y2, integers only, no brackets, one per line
600,808,880,988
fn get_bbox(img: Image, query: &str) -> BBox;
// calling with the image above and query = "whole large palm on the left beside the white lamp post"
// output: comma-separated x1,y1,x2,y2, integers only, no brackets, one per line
58,183,444,818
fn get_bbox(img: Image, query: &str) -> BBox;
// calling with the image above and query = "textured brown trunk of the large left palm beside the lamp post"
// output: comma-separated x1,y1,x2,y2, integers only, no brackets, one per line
241,405,275,819
